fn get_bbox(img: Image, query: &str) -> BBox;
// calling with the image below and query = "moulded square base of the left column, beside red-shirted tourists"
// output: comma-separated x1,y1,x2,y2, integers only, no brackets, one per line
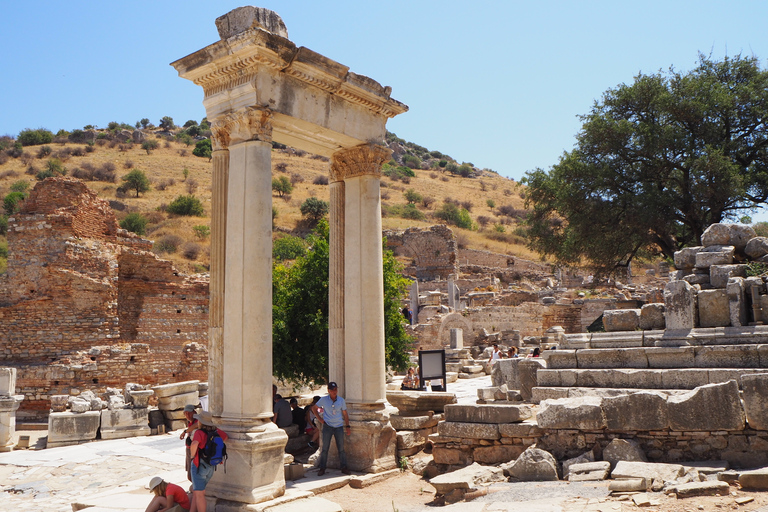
206,422,288,504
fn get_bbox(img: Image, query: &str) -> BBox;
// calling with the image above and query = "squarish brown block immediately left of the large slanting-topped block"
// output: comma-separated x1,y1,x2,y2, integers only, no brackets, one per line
602,391,669,432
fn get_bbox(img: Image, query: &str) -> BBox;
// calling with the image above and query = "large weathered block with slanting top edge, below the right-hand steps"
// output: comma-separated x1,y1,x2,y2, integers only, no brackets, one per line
667,380,744,431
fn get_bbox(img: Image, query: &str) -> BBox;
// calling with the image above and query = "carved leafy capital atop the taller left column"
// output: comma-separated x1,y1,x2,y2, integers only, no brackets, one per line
211,107,272,149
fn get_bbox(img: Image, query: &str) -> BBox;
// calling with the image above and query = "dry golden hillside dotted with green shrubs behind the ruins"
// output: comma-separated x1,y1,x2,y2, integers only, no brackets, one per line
0,129,537,272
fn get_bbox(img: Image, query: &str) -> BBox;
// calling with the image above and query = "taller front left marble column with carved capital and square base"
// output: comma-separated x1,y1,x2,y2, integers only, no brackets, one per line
206,107,287,503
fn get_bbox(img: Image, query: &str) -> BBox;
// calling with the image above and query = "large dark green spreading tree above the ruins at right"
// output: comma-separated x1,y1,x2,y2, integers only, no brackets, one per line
524,55,768,276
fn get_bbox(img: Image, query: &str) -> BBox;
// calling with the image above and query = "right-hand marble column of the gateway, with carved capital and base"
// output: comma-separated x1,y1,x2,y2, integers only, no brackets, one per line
329,144,396,472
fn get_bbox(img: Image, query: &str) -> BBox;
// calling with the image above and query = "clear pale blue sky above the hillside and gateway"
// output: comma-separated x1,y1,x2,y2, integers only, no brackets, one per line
0,0,768,198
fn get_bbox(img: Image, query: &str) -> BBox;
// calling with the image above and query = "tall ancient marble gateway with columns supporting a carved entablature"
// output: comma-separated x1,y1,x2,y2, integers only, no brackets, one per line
172,7,407,503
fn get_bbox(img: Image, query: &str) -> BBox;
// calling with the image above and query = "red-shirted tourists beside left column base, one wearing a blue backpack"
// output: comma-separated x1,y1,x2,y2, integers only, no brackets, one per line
146,405,228,512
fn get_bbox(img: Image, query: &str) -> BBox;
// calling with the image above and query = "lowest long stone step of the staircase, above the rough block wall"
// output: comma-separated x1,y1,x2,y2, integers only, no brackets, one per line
536,367,768,389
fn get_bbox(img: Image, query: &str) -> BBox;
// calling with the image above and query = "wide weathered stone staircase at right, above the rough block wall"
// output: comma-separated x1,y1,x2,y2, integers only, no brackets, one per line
531,325,768,403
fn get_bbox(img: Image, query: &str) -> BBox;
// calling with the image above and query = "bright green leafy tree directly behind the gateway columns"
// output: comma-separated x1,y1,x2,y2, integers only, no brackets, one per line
272,222,412,384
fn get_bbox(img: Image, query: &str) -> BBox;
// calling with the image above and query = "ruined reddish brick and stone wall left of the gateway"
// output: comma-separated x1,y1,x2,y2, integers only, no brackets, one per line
0,178,208,420
